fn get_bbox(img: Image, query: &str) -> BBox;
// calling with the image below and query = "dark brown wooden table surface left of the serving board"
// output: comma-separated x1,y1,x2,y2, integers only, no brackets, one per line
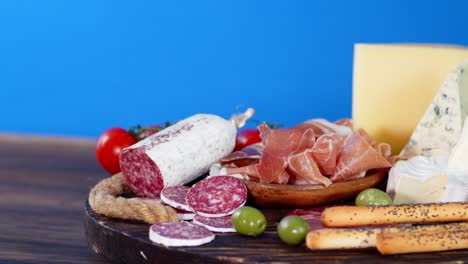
0,135,109,263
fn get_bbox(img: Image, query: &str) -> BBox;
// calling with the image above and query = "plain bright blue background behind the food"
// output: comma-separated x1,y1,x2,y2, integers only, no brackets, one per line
0,0,468,137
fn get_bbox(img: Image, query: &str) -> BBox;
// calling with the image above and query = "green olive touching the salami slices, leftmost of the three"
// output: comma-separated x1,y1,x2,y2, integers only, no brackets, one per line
231,206,267,236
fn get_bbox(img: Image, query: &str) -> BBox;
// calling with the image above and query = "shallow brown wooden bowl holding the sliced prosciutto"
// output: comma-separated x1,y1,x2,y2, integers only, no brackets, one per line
244,171,388,208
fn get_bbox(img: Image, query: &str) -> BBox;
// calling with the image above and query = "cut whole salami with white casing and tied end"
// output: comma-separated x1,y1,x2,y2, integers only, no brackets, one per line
120,109,254,198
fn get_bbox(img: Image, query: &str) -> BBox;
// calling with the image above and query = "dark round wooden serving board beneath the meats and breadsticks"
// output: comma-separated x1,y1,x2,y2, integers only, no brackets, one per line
85,203,468,264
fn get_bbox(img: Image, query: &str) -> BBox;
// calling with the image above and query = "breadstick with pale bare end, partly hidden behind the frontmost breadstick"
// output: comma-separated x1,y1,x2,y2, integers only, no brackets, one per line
306,222,468,250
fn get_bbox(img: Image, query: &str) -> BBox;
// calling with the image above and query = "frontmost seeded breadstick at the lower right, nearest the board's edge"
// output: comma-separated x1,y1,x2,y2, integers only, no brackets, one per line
376,225,468,255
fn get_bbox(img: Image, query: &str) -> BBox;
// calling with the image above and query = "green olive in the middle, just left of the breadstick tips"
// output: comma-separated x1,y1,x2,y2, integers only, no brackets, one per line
278,215,310,245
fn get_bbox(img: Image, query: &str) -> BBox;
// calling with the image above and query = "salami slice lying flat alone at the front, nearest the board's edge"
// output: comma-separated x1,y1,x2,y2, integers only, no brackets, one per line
149,221,215,247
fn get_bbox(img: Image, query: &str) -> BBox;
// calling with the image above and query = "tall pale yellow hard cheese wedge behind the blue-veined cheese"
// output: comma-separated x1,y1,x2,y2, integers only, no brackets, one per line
353,44,468,154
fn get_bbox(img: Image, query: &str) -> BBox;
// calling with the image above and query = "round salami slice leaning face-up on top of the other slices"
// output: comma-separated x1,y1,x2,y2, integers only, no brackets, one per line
187,176,247,217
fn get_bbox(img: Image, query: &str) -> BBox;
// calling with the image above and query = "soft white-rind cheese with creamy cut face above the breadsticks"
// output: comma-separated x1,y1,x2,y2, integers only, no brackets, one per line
387,156,468,204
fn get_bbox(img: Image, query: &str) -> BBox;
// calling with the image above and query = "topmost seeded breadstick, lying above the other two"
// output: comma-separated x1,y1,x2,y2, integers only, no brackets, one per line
322,203,468,227
